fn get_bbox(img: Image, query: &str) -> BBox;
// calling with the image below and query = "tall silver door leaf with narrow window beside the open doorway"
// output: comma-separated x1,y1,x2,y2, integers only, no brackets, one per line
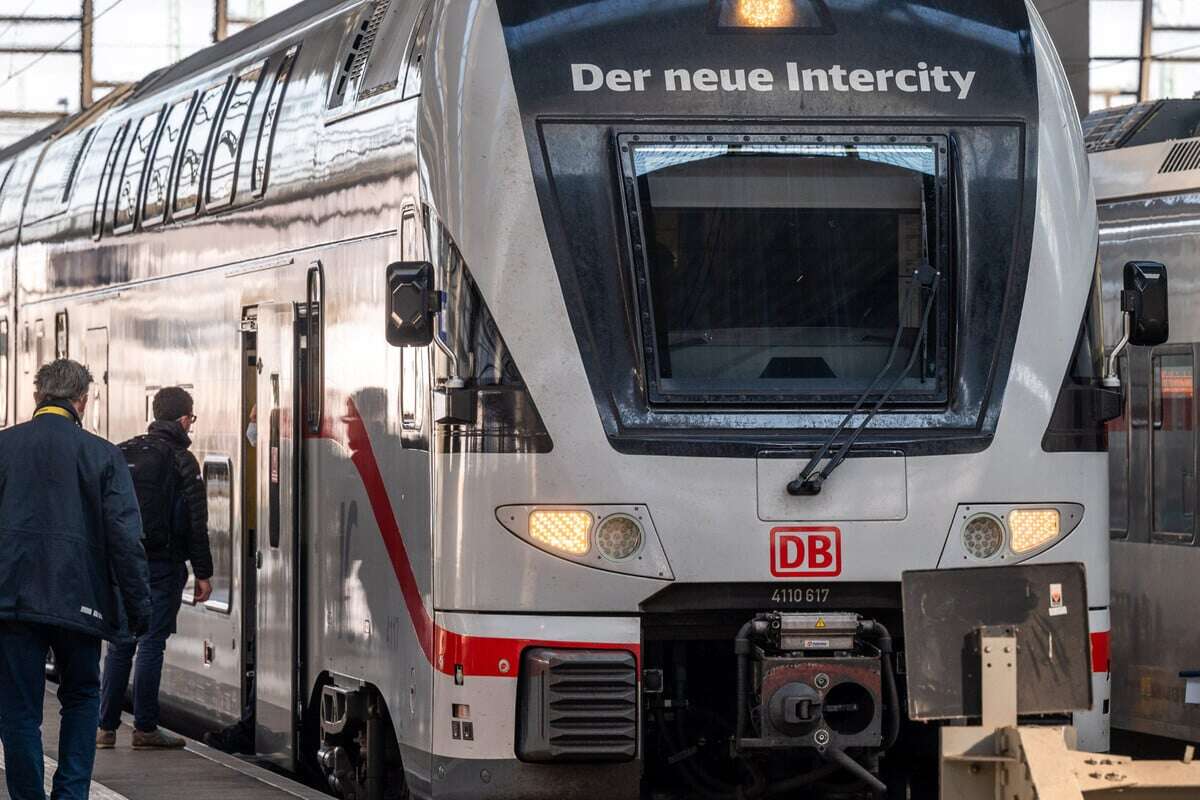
254,303,300,770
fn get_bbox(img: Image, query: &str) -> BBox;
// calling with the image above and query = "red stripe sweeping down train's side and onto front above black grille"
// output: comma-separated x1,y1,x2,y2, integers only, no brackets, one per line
317,399,641,678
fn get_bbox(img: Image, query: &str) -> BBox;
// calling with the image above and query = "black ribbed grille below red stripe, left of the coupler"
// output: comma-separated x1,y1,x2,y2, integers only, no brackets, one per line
517,648,637,762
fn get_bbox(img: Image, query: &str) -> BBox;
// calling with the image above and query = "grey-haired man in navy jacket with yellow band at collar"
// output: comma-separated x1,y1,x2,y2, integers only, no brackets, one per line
0,359,150,800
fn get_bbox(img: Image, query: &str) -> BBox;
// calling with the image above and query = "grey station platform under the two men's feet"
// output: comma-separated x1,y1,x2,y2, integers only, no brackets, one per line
0,684,330,800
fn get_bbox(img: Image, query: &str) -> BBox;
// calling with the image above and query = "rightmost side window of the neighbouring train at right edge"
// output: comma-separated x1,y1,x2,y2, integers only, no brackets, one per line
1151,350,1196,545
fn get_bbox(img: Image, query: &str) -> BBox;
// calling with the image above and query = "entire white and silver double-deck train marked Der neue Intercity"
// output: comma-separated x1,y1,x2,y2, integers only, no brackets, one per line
0,0,1109,799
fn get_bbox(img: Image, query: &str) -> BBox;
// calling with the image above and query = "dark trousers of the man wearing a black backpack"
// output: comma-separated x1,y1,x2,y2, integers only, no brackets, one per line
100,561,187,733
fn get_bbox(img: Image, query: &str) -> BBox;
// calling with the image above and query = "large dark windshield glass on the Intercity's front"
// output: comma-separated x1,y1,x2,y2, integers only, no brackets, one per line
626,137,949,402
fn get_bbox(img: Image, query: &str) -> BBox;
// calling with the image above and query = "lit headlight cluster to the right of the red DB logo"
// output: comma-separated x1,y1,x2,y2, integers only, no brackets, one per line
960,504,1082,561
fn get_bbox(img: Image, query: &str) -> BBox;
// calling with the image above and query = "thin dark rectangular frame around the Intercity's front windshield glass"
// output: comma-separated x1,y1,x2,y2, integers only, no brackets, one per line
616,128,958,410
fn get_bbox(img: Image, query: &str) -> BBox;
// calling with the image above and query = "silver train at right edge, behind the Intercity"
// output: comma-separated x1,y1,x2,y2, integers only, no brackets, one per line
1088,101,1200,740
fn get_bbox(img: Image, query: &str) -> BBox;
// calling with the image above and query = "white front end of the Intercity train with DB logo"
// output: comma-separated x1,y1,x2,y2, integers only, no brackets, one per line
406,0,1108,799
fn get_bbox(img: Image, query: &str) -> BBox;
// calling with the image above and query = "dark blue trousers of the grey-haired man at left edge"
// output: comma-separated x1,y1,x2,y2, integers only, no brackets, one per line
0,621,100,800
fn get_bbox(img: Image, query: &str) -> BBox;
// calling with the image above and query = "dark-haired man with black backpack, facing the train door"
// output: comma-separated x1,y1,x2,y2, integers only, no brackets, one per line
96,386,212,750
